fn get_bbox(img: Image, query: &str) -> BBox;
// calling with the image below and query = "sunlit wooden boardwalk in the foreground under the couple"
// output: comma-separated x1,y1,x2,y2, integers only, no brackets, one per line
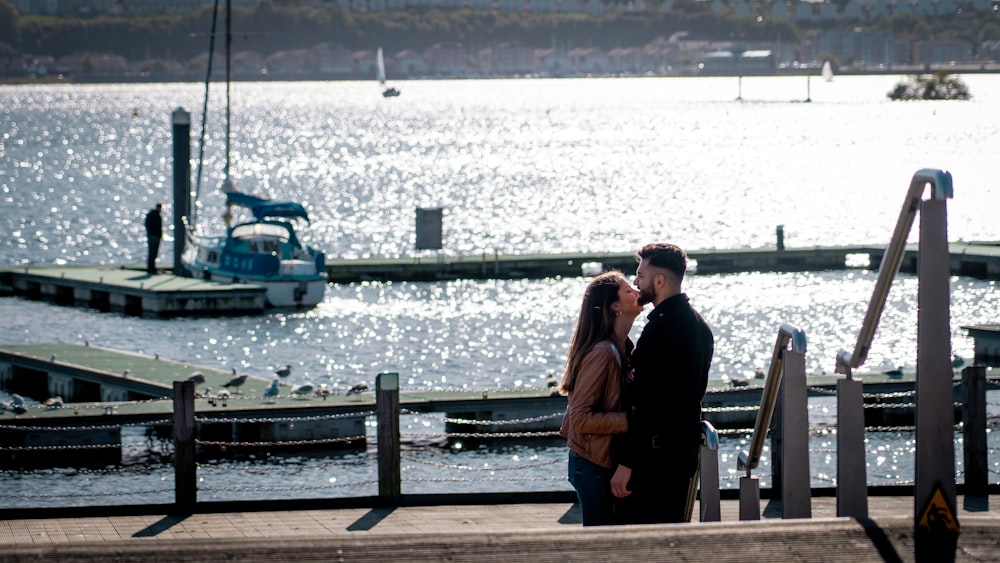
0,497,1000,563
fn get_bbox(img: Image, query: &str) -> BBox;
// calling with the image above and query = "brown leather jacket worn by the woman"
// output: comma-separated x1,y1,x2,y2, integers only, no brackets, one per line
559,340,628,468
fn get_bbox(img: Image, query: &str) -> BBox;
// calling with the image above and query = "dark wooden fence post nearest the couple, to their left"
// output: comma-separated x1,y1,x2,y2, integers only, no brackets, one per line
375,373,402,499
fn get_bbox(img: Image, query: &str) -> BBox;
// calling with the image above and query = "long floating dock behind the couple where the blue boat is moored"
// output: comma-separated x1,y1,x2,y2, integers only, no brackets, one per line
0,243,1000,318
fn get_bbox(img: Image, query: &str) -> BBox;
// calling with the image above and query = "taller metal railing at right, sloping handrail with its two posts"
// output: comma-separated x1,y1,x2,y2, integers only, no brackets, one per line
836,168,955,519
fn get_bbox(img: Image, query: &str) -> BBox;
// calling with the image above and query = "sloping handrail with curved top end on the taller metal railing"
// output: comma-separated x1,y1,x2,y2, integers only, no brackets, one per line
835,168,954,379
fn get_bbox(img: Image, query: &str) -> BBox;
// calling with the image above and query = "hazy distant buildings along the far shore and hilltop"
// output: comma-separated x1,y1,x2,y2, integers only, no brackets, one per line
0,0,1000,79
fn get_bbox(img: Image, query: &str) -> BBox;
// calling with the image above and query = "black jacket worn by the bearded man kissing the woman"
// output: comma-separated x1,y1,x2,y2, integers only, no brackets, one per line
617,293,715,470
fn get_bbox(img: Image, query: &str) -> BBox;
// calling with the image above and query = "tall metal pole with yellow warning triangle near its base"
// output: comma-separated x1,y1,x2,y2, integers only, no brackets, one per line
914,198,959,560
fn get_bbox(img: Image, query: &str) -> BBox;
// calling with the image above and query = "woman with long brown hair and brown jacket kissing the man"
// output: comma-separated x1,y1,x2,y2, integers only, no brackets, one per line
559,272,642,526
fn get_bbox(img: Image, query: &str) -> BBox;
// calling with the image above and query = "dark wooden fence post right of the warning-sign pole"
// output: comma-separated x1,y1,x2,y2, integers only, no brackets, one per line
962,366,989,498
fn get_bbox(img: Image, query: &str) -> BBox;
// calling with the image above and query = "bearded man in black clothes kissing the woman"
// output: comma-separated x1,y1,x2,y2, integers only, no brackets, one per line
611,243,715,524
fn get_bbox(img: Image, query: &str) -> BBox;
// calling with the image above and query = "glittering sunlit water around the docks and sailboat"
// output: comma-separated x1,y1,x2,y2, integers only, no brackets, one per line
0,75,1000,505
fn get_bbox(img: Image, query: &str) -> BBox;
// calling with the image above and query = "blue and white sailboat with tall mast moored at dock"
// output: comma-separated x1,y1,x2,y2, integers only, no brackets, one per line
181,1,327,309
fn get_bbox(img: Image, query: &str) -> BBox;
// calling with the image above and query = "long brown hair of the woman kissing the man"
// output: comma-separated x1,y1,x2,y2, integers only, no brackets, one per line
559,271,625,395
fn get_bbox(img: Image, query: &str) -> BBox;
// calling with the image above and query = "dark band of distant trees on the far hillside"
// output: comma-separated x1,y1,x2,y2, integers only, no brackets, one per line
0,0,1000,63
